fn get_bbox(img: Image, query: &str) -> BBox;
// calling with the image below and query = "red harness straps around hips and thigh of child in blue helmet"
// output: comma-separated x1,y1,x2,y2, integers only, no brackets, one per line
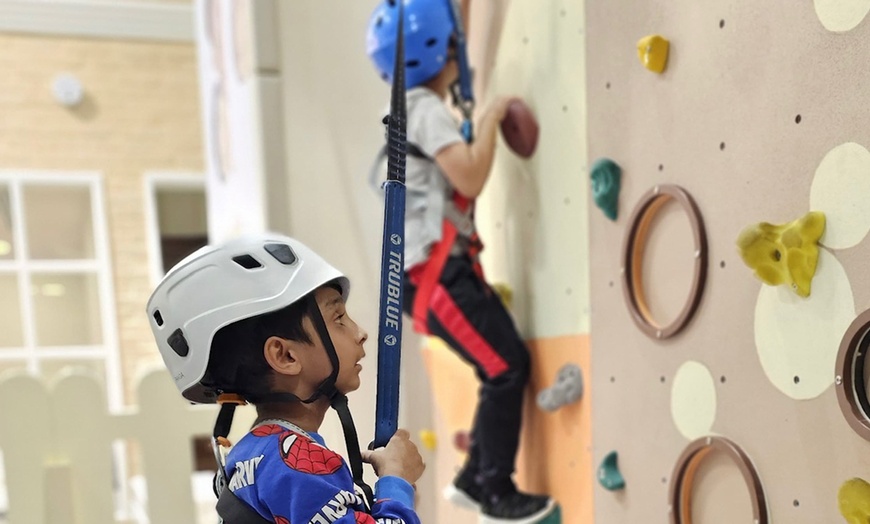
409,191,483,335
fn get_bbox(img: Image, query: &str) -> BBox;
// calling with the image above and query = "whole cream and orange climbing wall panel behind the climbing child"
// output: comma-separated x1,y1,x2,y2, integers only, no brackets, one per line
480,0,593,524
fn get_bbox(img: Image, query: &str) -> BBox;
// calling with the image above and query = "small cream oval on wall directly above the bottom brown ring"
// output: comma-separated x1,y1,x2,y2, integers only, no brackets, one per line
671,360,716,440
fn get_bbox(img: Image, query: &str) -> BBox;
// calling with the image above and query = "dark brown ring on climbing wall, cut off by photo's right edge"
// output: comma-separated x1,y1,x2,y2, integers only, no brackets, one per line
834,310,870,440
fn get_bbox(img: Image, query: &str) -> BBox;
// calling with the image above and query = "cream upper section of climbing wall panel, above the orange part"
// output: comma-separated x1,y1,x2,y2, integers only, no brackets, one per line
472,0,589,338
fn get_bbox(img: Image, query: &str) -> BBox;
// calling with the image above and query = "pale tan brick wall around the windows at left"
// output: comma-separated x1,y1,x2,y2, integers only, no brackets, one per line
0,34,203,400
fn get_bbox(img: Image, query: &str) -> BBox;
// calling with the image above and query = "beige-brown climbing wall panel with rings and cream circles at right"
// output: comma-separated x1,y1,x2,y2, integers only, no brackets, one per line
588,0,870,524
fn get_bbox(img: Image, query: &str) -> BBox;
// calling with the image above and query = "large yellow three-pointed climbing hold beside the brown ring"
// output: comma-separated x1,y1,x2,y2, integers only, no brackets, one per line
737,211,825,297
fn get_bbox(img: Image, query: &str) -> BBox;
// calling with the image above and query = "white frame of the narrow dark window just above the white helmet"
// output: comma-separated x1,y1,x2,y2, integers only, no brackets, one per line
144,171,208,288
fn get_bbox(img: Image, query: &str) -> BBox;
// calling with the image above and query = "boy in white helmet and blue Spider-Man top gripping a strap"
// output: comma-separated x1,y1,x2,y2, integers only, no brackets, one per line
147,234,424,524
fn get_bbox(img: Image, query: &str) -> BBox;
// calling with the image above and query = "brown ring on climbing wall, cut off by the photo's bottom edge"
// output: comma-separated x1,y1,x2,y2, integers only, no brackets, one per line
668,437,770,524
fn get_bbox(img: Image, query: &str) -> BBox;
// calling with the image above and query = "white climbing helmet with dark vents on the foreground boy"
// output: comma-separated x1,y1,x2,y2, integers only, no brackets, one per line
147,233,350,403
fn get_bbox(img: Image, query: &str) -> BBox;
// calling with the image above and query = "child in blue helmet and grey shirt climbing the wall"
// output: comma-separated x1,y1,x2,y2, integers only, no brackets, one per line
367,0,555,524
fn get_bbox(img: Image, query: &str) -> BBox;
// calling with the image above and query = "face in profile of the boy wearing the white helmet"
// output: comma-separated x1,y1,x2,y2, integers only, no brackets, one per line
314,287,368,393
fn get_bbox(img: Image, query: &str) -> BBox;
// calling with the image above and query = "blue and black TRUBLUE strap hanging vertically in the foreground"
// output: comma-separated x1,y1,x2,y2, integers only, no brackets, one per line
372,2,408,448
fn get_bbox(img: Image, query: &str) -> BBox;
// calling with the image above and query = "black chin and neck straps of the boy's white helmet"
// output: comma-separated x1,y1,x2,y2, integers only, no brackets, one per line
212,293,374,507
